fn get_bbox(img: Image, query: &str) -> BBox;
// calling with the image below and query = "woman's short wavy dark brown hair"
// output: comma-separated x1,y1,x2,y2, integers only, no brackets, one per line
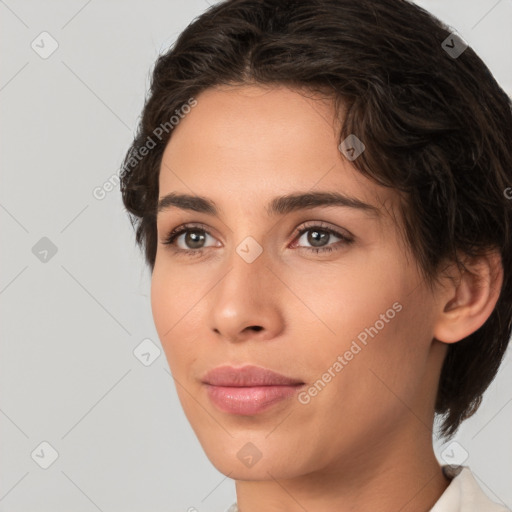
121,0,512,437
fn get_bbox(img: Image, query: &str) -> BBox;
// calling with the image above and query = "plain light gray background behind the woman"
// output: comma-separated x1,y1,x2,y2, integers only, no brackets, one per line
0,0,512,512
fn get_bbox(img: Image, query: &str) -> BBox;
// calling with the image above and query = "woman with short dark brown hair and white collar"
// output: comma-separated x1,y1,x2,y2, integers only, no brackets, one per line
121,0,512,512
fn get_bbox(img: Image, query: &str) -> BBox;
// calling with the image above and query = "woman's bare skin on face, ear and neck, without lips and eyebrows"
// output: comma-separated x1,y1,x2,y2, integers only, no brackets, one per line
151,85,502,512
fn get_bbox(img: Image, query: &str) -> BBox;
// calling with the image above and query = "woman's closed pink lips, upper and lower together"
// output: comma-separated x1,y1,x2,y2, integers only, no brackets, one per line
202,365,304,415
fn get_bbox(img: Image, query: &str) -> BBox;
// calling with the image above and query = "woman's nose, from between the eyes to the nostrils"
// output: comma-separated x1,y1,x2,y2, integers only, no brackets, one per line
210,243,284,342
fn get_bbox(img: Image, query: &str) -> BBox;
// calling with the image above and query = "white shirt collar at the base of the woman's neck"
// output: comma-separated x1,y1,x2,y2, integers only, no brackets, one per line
226,466,511,512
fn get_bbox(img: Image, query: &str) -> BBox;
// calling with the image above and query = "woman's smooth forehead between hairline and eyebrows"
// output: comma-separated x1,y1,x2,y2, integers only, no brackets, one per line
160,86,396,218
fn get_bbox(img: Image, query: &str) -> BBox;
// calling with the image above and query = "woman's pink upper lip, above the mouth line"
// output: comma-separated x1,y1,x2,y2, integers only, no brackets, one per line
202,365,304,387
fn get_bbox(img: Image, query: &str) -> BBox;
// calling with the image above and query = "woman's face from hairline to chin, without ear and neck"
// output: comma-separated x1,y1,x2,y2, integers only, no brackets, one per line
151,86,444,480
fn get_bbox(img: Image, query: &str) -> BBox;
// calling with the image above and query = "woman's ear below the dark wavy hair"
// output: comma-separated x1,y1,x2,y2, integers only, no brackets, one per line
434,250,503,343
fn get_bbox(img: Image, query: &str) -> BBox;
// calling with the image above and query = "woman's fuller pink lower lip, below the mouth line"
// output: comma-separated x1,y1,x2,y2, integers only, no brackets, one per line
206,384,303,416
